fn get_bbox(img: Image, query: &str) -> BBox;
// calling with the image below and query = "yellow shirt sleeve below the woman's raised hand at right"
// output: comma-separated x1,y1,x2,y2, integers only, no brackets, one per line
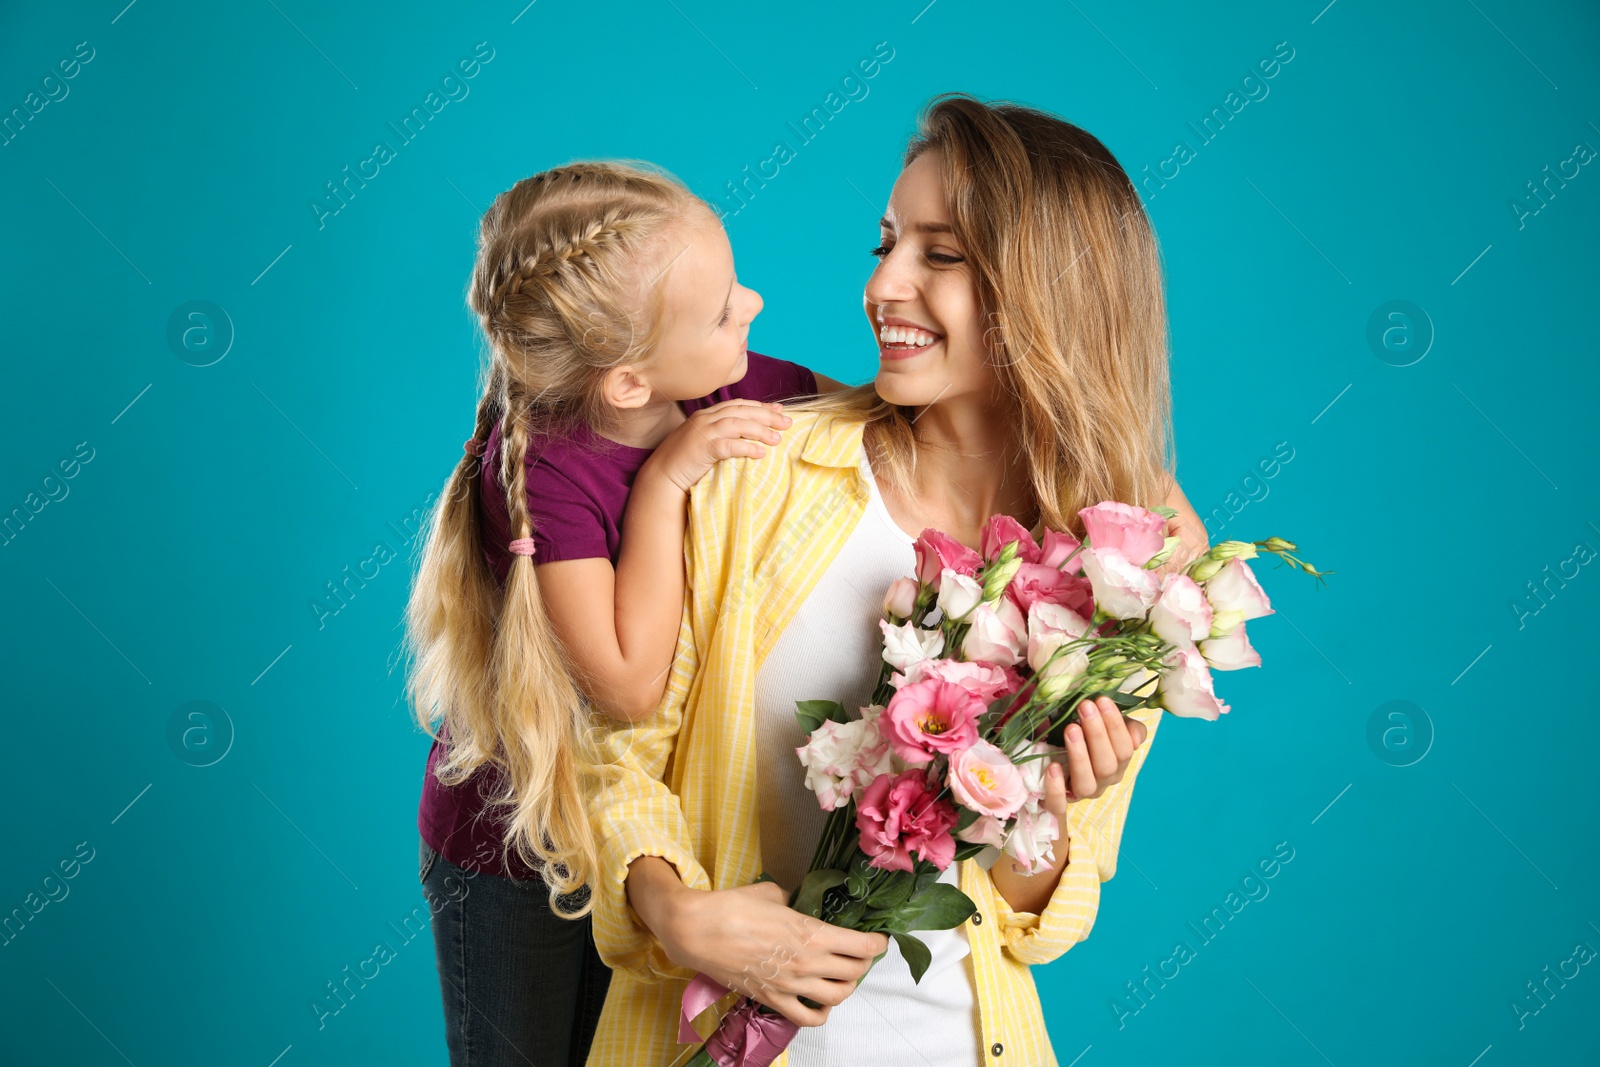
995,707,1162,965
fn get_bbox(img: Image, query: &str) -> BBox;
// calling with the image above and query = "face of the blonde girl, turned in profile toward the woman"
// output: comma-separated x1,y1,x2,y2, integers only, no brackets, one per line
637,211,762,400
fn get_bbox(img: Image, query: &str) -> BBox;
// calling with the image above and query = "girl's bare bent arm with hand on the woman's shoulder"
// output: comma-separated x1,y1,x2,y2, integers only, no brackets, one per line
536,400,790,721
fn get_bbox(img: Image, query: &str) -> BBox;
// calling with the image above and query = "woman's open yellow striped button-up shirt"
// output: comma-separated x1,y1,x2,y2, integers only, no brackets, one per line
589,413,1160,1067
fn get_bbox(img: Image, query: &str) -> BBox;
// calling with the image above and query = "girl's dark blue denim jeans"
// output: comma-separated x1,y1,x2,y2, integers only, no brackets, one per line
419,841,611,1067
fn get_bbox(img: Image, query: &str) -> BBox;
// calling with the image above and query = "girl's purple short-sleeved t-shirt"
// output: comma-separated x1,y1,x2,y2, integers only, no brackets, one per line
418,352,816,880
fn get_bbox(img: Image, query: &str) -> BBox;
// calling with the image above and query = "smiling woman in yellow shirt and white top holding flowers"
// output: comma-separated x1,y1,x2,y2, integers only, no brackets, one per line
589,94,1205,1067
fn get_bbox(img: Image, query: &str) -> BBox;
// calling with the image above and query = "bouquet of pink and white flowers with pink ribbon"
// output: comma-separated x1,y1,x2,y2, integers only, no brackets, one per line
678,501,1331,1067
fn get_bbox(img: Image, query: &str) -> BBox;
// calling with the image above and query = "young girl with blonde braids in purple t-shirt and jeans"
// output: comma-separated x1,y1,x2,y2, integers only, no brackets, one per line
408,163,837,1067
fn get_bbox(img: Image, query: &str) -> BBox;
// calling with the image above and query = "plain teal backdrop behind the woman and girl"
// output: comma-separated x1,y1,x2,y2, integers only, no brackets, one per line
0,0,1600,1067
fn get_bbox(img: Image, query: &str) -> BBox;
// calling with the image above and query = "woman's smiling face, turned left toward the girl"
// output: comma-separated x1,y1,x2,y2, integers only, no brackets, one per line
862,150,995,406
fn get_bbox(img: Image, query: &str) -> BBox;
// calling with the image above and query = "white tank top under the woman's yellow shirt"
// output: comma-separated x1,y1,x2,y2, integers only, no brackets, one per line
755,450,982,1067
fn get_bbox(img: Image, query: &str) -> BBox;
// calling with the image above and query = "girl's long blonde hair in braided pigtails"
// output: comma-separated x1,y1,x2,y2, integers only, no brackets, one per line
406,162,709,918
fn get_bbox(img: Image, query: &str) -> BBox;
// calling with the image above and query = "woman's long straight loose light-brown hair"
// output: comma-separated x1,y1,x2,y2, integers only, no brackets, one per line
792,93,1176,536
